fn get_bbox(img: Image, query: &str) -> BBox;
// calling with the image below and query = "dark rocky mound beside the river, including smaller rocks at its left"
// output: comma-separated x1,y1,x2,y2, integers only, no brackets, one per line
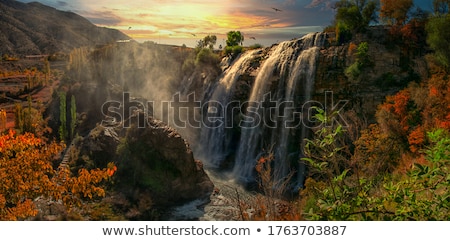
70,119,214,220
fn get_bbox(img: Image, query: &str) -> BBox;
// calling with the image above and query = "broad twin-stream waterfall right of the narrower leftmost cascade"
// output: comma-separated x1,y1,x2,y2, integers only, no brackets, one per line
233,33,325,184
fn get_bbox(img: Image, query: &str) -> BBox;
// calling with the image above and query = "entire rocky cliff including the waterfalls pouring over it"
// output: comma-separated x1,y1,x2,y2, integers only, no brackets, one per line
190,27,428,186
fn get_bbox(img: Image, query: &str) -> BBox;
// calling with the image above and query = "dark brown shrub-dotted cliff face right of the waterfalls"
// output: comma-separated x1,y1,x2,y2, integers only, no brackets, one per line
313,27,428,122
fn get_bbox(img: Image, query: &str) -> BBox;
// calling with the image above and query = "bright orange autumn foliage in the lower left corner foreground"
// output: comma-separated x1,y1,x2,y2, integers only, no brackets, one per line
0,130,116,220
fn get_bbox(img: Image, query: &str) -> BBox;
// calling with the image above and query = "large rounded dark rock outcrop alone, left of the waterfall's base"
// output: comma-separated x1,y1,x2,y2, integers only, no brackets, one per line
118,118,214,206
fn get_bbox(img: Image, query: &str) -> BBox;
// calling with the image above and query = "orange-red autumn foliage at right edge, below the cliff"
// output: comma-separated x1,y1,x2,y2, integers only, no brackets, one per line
370,64,450,168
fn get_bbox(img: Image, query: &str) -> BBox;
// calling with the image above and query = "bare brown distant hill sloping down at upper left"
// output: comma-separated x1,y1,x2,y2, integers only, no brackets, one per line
0,0,130,55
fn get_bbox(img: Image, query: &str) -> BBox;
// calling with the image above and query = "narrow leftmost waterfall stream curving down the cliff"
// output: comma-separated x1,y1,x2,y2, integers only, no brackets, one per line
200,50,261,168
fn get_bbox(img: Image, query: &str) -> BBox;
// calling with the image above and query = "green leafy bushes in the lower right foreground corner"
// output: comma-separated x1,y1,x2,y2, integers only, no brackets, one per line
301,105,450,221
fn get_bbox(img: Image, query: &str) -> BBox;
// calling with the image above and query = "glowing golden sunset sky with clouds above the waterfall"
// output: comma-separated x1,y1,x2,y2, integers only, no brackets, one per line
21,0,432,47
